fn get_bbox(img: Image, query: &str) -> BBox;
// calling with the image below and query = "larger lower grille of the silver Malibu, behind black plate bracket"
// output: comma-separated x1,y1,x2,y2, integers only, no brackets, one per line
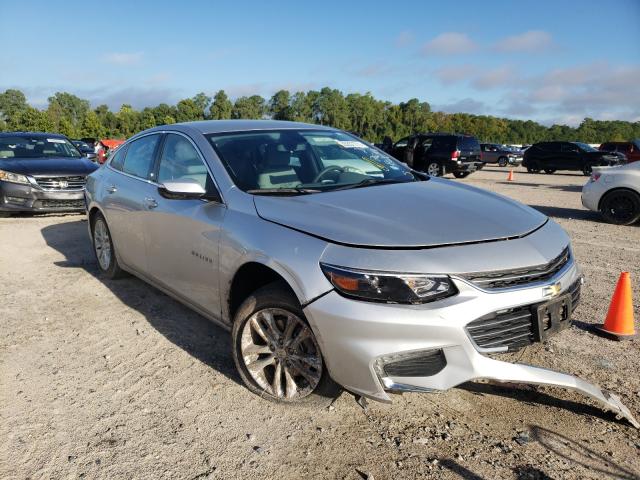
466,279,582,352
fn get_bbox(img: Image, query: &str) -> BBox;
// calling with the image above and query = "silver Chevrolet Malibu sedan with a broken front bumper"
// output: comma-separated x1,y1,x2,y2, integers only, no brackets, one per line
86,120,633,421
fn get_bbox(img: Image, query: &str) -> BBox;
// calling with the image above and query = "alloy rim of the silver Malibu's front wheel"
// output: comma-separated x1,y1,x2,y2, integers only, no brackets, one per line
240,308,322,400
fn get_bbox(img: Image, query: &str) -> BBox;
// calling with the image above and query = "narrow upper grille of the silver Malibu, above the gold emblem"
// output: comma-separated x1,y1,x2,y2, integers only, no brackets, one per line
463,247,571,290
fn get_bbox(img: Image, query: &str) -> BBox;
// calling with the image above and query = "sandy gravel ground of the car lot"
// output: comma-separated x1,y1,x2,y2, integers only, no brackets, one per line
0,168,640,480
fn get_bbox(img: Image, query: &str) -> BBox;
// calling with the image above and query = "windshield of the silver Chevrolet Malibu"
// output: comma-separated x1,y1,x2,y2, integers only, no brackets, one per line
207,130,418,194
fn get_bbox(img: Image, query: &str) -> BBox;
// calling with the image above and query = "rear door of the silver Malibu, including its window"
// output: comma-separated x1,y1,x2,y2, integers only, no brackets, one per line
103,134,160,273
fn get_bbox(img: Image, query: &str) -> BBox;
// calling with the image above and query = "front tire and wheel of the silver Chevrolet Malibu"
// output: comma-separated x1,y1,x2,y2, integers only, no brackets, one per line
232,282,340,404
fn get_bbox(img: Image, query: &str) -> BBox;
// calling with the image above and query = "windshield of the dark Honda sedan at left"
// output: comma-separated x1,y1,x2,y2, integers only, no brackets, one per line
0,135,82,159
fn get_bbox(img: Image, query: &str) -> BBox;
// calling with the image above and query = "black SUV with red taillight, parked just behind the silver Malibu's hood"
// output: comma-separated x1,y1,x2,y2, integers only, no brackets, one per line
390,133,484,178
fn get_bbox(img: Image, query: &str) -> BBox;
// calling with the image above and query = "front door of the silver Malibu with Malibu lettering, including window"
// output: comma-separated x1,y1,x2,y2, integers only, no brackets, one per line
144,132,226,317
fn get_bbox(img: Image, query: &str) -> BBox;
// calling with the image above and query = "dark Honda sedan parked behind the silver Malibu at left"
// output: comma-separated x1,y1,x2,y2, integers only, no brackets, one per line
0,132,98,216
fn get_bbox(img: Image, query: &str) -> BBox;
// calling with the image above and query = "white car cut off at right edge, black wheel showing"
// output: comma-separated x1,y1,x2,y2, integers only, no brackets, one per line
582,162,640,225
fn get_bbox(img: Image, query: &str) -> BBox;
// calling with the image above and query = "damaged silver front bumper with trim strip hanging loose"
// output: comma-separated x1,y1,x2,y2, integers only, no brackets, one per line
304,262,640,428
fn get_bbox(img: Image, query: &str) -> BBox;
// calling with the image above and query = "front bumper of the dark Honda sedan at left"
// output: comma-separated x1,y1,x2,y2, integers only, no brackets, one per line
0,181,85,212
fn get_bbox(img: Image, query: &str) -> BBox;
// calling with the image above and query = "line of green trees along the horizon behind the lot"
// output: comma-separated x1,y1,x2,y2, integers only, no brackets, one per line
0,87,640,144
